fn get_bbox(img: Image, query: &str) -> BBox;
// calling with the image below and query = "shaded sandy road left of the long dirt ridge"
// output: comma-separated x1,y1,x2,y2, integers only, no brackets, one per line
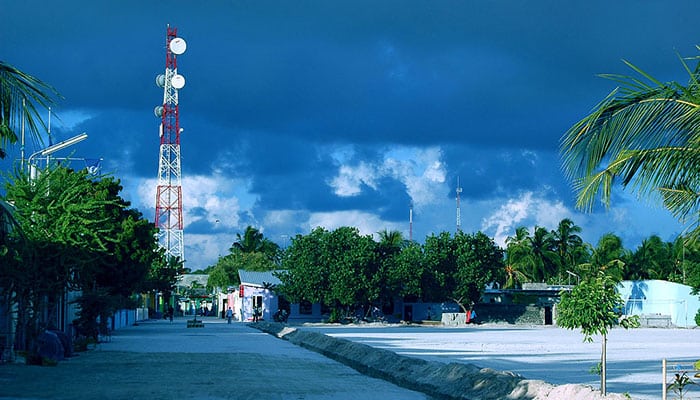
0,319,428,400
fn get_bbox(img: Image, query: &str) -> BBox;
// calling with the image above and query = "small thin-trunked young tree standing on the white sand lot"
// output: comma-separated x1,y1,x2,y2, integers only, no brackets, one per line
557,271,639,395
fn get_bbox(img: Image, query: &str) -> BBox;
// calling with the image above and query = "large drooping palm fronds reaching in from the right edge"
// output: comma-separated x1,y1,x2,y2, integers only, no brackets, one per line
561,47,700,239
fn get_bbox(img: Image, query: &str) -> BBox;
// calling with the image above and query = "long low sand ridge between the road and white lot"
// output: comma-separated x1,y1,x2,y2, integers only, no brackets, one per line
251,322,626,400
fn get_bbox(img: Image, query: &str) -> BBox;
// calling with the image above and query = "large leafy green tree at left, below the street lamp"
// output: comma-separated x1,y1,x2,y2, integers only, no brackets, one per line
0,166,158,354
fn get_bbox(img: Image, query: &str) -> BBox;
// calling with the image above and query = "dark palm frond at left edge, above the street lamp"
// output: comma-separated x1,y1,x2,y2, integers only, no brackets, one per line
0,61,60,158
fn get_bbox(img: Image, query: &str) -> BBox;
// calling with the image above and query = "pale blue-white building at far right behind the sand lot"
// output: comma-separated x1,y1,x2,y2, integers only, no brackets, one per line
618,280,700,328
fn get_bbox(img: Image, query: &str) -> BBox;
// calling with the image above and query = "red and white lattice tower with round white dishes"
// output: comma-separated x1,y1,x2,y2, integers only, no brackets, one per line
155,26,187,262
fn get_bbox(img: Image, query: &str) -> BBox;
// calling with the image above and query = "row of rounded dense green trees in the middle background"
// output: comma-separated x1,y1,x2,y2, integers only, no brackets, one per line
278,227,503,320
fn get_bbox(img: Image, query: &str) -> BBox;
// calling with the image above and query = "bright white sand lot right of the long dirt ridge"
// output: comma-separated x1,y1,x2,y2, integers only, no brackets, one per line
301,324,700,400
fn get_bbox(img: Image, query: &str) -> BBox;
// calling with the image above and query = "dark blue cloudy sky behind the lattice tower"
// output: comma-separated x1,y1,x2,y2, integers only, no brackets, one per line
0,0,700,270
